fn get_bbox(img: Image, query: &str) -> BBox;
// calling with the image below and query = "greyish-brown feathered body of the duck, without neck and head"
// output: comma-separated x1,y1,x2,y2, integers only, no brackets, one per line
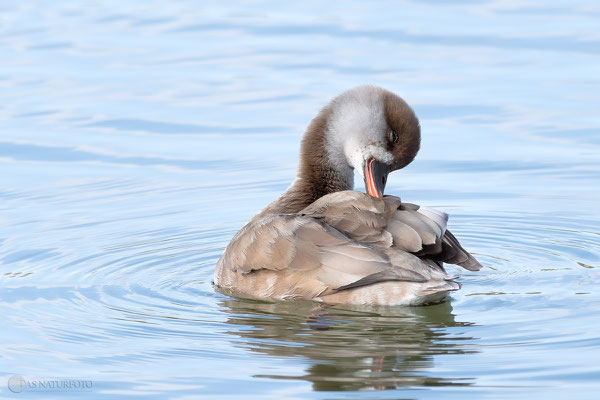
214,191,481,305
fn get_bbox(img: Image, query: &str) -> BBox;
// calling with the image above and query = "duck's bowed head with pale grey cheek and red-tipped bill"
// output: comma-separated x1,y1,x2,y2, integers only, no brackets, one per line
303,86,421,197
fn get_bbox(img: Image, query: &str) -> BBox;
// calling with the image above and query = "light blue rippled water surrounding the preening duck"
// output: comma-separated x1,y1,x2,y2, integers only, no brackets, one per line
0,0,600,399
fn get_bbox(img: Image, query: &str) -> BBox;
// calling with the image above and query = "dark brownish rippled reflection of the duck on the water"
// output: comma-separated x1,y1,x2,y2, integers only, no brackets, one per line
221,299,471,390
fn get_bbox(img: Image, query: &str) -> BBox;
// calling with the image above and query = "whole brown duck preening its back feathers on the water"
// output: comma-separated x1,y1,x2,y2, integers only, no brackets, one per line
213,86,482,306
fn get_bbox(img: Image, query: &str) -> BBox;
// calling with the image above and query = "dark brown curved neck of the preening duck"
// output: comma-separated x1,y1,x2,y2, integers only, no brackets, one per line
257,107,354,217
